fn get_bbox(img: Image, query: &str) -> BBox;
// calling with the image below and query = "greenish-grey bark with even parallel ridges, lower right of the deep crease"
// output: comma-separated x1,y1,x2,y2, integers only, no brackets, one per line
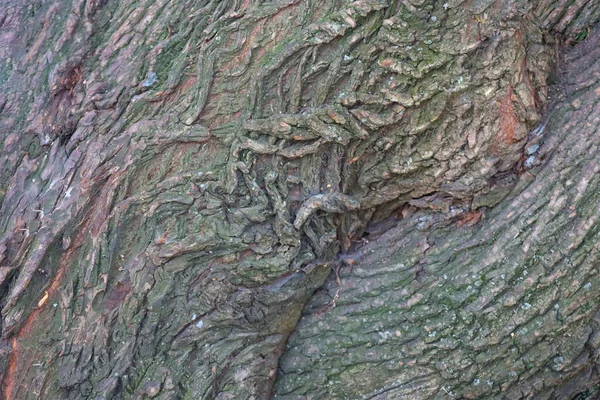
277,36,600,399
